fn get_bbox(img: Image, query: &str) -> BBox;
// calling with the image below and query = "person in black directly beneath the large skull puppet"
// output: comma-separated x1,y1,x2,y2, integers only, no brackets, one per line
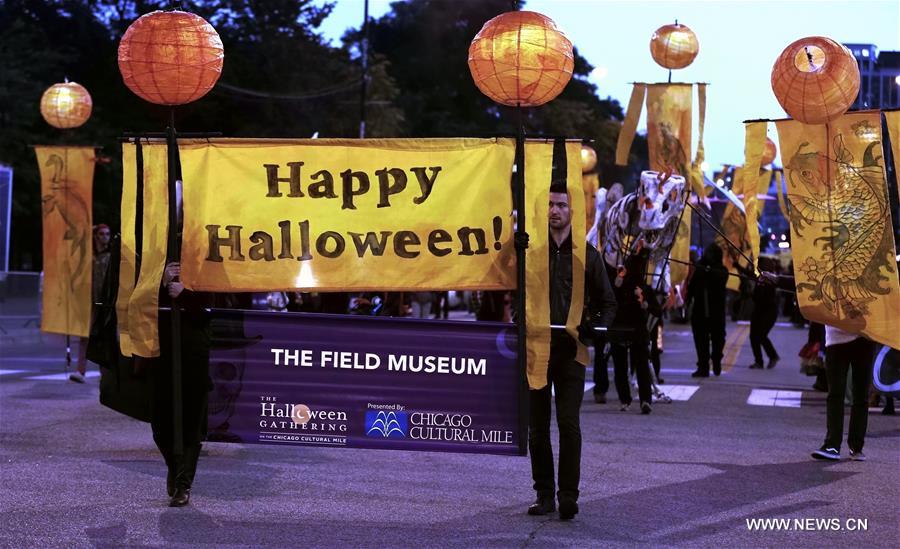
611,241,662,414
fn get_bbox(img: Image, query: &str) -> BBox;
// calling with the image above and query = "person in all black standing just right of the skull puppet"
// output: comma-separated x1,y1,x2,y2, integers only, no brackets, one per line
688,243,728,377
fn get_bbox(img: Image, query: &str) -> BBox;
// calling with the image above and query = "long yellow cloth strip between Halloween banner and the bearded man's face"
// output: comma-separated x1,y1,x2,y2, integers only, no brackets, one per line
525,143,556,389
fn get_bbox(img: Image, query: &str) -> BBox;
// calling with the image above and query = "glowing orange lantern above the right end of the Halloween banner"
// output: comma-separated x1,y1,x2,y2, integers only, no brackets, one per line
469,11,575,107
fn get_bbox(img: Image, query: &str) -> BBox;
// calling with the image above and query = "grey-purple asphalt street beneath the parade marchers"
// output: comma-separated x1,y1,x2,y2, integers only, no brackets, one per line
0,318,900,548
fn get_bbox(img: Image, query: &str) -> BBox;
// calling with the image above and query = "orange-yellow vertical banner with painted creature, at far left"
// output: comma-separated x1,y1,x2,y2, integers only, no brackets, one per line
35,147,94,337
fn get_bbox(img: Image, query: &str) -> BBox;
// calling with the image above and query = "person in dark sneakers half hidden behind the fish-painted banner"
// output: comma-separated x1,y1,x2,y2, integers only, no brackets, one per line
812,325,875,461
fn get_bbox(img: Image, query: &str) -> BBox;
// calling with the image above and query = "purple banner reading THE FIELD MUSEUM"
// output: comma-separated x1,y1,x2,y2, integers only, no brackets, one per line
208,310,526,455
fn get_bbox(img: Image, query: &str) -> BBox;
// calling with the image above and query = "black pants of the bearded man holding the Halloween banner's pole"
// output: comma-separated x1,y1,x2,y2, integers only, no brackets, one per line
528,352,584,501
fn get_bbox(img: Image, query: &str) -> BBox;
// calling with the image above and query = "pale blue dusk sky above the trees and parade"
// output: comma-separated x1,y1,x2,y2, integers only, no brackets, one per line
322,0,900,169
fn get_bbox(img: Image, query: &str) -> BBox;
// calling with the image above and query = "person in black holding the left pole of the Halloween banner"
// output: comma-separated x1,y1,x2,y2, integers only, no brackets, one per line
149,262,212,507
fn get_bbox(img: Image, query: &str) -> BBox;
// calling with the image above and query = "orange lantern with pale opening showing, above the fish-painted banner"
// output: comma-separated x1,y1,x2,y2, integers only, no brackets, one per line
772,36,859,124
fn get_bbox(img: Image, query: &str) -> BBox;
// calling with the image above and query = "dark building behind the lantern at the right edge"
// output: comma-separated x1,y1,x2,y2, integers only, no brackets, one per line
844,44,900,110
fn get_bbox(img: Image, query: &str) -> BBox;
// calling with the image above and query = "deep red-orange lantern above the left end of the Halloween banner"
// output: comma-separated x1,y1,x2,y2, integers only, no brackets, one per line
119,11,225,105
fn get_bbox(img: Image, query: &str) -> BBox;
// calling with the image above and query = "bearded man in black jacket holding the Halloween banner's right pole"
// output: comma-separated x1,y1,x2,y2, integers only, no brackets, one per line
528,181,616,520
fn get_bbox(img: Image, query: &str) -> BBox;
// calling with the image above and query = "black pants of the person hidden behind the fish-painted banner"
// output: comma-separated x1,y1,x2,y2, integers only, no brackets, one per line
825,337,875,452
